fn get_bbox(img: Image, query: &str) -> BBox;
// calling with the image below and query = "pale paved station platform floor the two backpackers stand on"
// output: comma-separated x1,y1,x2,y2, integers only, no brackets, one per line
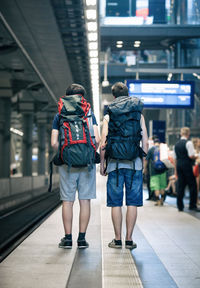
0,175,200,288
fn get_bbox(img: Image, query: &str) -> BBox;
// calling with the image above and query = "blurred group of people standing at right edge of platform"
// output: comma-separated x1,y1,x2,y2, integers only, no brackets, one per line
144,127,200,212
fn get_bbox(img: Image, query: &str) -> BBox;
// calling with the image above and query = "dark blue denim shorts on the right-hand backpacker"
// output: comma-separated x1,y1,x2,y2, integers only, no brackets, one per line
107,168,143,207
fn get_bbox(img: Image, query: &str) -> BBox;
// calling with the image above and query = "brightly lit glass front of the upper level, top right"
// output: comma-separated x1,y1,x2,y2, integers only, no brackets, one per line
100,0,200,25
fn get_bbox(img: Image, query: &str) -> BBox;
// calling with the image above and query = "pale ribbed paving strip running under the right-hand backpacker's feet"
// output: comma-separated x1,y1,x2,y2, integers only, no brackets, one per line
101,190,143,288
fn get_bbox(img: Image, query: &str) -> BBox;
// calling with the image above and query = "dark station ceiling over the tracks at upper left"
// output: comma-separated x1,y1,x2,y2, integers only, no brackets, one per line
0,0,92,113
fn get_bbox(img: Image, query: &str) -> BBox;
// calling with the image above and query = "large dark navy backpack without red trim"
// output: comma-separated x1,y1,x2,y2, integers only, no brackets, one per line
106,96,144,161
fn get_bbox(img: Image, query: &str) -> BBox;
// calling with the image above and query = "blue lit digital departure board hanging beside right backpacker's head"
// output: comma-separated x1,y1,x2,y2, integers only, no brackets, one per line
127,80,194,108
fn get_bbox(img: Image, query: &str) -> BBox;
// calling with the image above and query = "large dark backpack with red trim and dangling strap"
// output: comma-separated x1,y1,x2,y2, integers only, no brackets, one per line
49,95,96,191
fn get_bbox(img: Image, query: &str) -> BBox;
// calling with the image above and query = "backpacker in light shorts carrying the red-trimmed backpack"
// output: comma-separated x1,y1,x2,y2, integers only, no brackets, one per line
51,84,100,249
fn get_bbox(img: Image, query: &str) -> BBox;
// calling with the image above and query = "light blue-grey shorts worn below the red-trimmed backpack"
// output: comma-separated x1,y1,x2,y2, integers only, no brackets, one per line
59,165,96,202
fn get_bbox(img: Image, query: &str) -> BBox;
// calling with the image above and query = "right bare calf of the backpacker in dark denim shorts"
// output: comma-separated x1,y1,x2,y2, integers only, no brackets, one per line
126,206,137,241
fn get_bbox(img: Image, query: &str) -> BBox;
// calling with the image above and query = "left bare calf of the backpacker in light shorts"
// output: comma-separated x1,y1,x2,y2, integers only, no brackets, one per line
62,201,74,234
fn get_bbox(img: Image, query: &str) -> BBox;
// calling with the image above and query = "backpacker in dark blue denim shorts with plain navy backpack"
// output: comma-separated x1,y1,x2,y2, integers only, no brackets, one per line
100,82,148,249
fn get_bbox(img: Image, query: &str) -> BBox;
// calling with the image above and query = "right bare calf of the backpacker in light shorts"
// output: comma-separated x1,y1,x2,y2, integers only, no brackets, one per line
79,200,90,233
